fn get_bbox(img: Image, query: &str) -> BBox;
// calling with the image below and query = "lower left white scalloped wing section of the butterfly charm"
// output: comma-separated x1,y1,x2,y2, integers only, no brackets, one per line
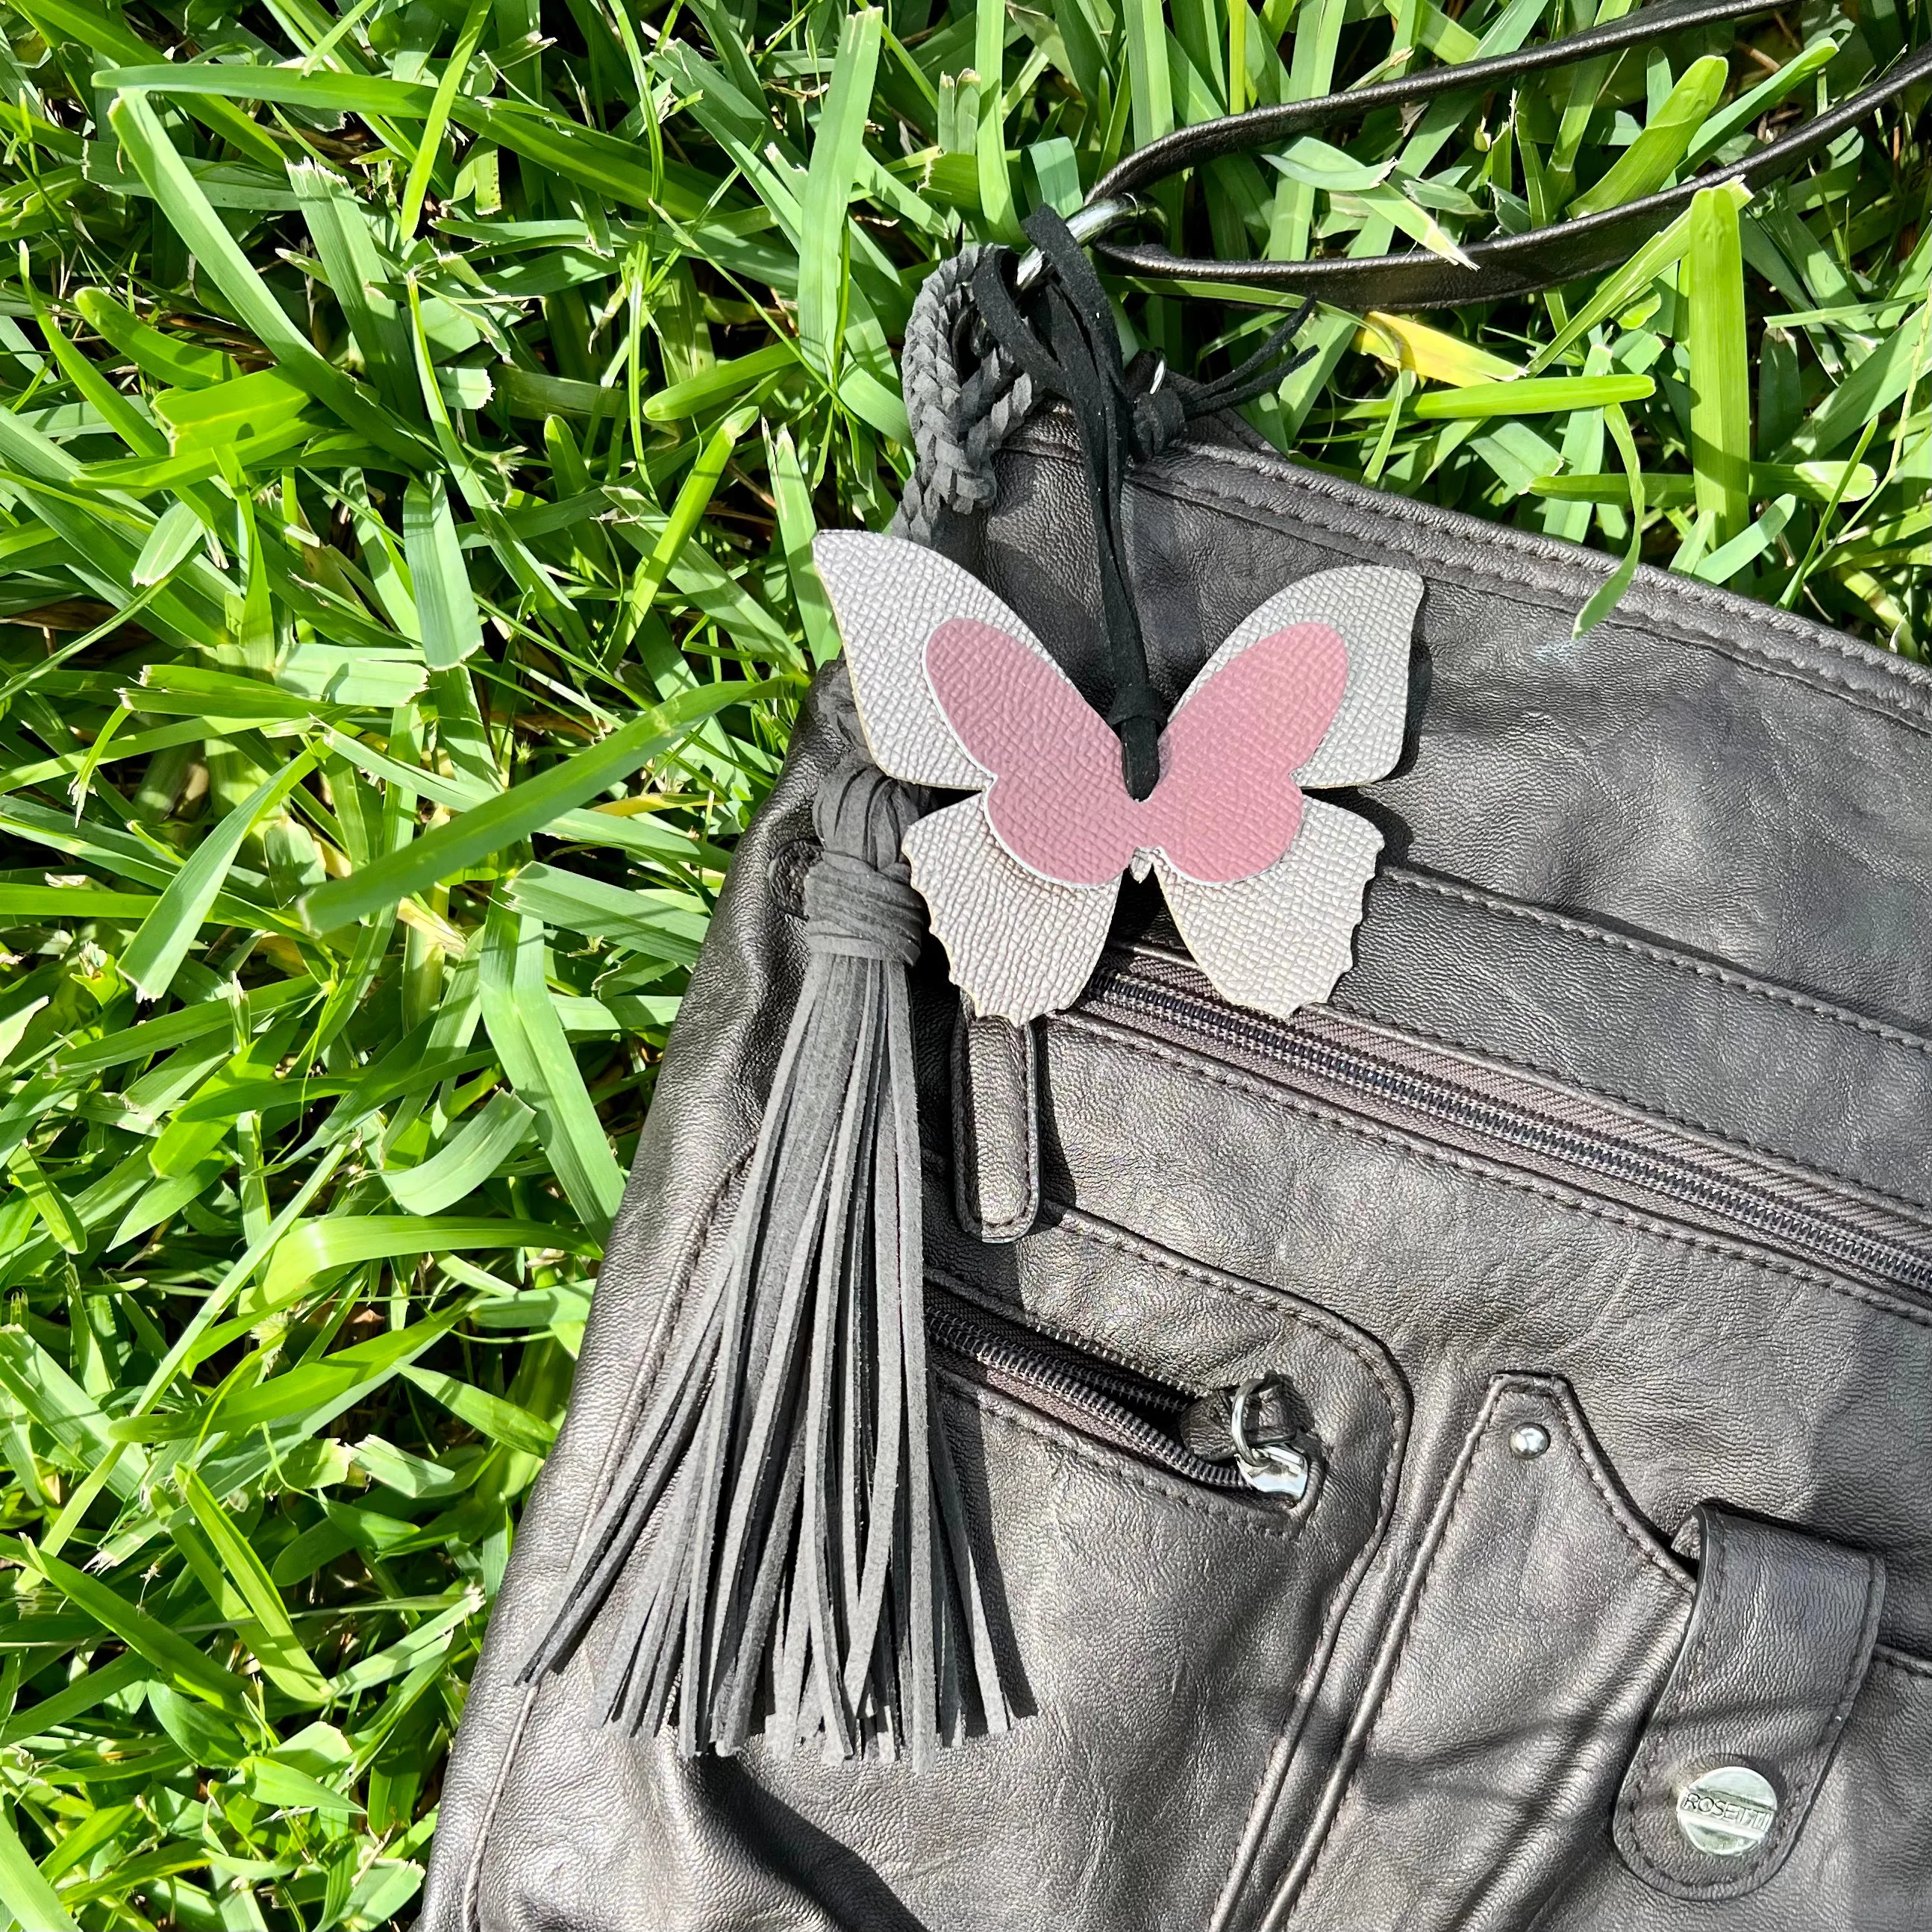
906,798,1121,1026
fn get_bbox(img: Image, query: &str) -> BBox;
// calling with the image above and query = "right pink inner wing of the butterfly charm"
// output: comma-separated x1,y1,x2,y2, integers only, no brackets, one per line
1148,624,1348,885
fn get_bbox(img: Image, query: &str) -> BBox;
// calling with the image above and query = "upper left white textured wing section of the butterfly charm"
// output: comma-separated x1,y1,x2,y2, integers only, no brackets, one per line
811,529,1053,792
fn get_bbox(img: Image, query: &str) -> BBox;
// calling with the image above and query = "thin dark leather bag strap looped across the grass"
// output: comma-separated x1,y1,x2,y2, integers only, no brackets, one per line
1088,0,1932,313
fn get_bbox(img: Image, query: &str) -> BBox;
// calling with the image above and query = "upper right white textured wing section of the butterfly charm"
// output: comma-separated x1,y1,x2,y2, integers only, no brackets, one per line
1175,564,1422,790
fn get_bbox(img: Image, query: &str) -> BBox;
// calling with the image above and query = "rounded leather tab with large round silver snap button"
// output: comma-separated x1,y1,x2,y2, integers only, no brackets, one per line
1615,1503,1886,1899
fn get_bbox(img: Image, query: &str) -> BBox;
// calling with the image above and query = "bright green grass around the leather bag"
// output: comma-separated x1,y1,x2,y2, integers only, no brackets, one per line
0,0,1932,1932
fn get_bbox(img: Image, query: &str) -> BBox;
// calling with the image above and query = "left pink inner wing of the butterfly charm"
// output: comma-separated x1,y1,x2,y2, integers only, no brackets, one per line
925,618,1136,885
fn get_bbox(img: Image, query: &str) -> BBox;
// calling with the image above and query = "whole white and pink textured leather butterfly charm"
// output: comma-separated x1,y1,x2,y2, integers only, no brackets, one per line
813,531,1422,1024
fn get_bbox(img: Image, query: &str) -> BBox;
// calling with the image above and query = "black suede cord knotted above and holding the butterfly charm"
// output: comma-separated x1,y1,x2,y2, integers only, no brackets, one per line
972,209,1308,798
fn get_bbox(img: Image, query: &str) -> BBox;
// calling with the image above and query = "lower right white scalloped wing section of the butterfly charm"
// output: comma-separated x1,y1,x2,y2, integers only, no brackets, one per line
1159,798,1381,1020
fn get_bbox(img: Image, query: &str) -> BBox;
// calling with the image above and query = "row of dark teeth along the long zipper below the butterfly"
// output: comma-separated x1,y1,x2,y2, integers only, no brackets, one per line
1090,962,1932,1289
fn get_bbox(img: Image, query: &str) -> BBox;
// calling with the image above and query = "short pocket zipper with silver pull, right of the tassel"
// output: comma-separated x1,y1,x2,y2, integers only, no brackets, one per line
925,1289,1312,1501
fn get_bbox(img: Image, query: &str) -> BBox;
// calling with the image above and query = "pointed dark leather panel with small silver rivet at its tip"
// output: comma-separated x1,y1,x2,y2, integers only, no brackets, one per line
1267,1375,1690,1932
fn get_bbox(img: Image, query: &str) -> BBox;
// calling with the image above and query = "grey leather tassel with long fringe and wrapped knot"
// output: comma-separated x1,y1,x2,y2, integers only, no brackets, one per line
522,755,1010,1766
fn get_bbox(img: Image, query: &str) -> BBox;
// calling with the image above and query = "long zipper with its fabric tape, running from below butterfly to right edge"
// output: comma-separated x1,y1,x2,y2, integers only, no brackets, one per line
1076,952,1932,1292
